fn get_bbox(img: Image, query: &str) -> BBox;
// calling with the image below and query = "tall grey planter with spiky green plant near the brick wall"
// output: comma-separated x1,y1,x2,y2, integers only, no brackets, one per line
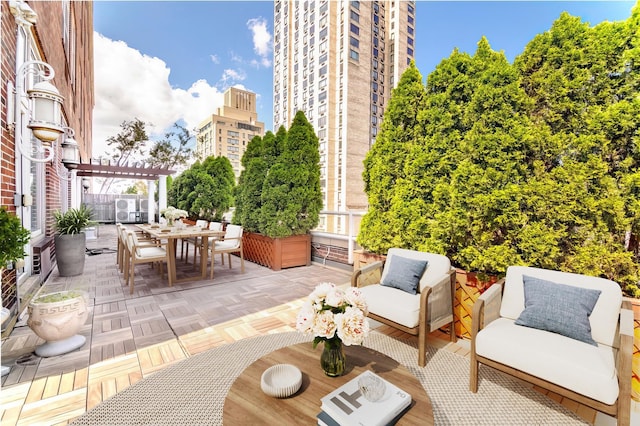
53,205,95,277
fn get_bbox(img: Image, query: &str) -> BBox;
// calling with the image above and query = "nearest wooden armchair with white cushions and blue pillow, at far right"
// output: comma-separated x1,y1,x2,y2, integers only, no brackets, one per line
469,266,633,426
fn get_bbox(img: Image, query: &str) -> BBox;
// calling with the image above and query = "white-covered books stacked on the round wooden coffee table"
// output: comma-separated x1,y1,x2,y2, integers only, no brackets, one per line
318,371,411,426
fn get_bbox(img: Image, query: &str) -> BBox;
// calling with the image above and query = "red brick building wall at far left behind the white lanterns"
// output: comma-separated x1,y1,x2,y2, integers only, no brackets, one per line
0,0,95,320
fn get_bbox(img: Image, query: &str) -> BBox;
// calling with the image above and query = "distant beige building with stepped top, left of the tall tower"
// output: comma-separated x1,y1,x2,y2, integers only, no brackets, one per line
196,87,264,180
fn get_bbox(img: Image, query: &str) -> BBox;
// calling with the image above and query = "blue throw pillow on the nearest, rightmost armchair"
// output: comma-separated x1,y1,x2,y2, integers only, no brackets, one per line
516,275,601,346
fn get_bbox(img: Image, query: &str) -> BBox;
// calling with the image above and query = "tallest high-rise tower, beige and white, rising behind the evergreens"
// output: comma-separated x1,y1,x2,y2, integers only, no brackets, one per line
273,0,415,231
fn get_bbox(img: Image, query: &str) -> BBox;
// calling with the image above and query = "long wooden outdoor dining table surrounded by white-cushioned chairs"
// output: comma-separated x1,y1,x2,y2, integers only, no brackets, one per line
136,224,224,283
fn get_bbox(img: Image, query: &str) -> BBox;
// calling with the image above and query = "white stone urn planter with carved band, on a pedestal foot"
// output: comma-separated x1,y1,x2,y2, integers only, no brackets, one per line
27,291,89,357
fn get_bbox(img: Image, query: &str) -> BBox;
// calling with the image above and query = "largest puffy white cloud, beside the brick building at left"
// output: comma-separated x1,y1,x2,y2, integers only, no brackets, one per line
93,32,225,157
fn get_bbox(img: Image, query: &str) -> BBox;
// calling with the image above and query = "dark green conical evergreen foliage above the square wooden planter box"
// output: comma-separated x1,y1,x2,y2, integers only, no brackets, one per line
233,111,322,238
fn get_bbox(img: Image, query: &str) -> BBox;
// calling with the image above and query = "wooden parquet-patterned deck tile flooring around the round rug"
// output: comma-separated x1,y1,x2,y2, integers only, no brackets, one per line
0,226,620,425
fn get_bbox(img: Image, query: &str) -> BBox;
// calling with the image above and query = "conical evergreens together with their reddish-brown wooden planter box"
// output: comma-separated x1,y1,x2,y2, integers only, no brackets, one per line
233,111,322,270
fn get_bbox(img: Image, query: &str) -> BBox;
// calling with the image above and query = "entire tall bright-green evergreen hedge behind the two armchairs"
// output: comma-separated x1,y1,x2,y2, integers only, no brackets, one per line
358,6,640,296
